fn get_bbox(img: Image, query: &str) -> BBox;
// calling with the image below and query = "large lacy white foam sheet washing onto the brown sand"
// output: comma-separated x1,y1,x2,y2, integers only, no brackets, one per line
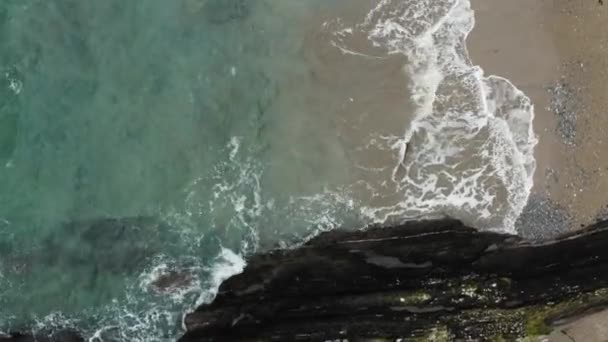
336,0,537,233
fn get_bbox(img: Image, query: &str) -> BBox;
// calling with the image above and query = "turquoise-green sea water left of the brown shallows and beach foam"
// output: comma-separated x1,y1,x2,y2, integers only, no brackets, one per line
0,0,366,341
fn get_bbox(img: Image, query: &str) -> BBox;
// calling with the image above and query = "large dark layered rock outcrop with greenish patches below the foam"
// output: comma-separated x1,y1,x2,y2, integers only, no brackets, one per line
180,220,608,342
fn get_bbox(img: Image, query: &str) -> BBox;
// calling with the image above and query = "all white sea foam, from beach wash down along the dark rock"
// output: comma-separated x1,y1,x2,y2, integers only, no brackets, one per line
0,0,536,342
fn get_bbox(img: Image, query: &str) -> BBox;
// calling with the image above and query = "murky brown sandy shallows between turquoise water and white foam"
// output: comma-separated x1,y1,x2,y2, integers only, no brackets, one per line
268,0,414,225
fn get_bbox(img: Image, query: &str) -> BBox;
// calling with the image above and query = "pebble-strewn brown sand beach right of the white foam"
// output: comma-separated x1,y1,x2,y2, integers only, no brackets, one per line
468,0,608,238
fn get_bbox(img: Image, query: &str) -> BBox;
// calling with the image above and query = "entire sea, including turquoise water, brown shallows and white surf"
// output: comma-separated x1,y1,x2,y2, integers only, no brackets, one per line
0,0,535,341
